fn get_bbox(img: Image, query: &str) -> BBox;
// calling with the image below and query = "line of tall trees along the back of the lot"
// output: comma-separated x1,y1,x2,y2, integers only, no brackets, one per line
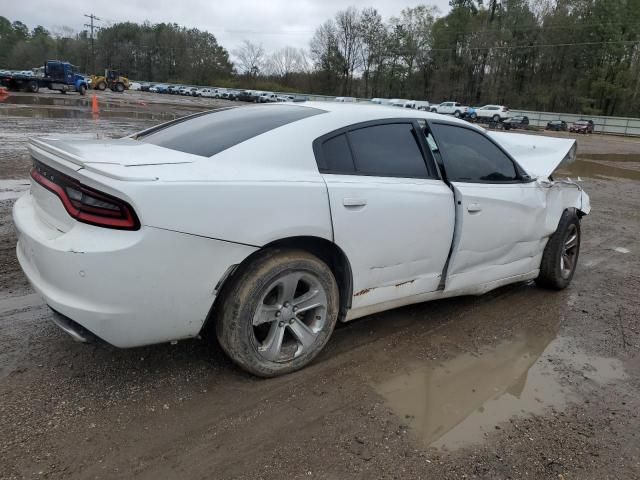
0,0,640,116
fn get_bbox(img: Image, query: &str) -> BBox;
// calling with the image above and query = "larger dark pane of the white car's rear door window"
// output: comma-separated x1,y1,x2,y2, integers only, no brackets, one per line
349,123,429,177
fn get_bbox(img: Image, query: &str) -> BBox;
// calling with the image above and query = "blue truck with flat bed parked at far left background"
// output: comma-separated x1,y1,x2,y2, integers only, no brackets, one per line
0,60,89,95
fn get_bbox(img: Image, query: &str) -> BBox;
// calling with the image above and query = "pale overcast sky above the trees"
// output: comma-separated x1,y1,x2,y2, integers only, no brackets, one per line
0,0,449,51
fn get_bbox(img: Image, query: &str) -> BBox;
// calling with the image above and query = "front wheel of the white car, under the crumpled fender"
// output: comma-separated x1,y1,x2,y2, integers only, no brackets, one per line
536,209,580,290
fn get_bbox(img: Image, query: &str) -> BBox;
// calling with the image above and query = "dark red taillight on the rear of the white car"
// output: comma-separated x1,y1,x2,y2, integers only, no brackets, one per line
31,162,140,230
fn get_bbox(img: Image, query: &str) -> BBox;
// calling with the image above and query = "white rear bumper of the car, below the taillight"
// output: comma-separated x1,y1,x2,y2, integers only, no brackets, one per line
13,194,255,347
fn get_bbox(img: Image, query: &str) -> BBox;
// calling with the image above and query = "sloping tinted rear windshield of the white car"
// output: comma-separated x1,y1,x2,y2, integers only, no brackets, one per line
135,105,325,157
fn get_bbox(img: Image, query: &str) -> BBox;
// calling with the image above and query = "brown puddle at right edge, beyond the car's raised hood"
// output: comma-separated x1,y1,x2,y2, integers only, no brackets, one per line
558,154,640,180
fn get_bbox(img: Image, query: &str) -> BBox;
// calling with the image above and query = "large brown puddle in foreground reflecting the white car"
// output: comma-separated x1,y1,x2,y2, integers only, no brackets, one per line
373,331,626,450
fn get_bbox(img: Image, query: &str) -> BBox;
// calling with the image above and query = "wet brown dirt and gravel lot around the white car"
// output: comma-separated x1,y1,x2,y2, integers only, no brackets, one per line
0,93,640,480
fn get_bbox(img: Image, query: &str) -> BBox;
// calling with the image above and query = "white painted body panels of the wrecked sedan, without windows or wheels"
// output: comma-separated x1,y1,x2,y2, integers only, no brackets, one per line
14,102,590,347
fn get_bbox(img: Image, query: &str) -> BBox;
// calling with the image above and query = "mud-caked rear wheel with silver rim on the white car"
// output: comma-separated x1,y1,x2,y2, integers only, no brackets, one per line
214,249,339,377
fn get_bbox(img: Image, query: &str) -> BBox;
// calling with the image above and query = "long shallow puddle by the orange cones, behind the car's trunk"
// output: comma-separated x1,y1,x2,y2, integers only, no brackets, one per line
0,107,180,122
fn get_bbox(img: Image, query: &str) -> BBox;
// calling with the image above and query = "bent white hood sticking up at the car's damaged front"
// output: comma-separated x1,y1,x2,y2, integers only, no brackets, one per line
488,132,576,178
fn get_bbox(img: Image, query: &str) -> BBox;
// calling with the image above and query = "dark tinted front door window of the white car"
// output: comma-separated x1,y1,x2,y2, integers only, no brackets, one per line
431,123,518,183
